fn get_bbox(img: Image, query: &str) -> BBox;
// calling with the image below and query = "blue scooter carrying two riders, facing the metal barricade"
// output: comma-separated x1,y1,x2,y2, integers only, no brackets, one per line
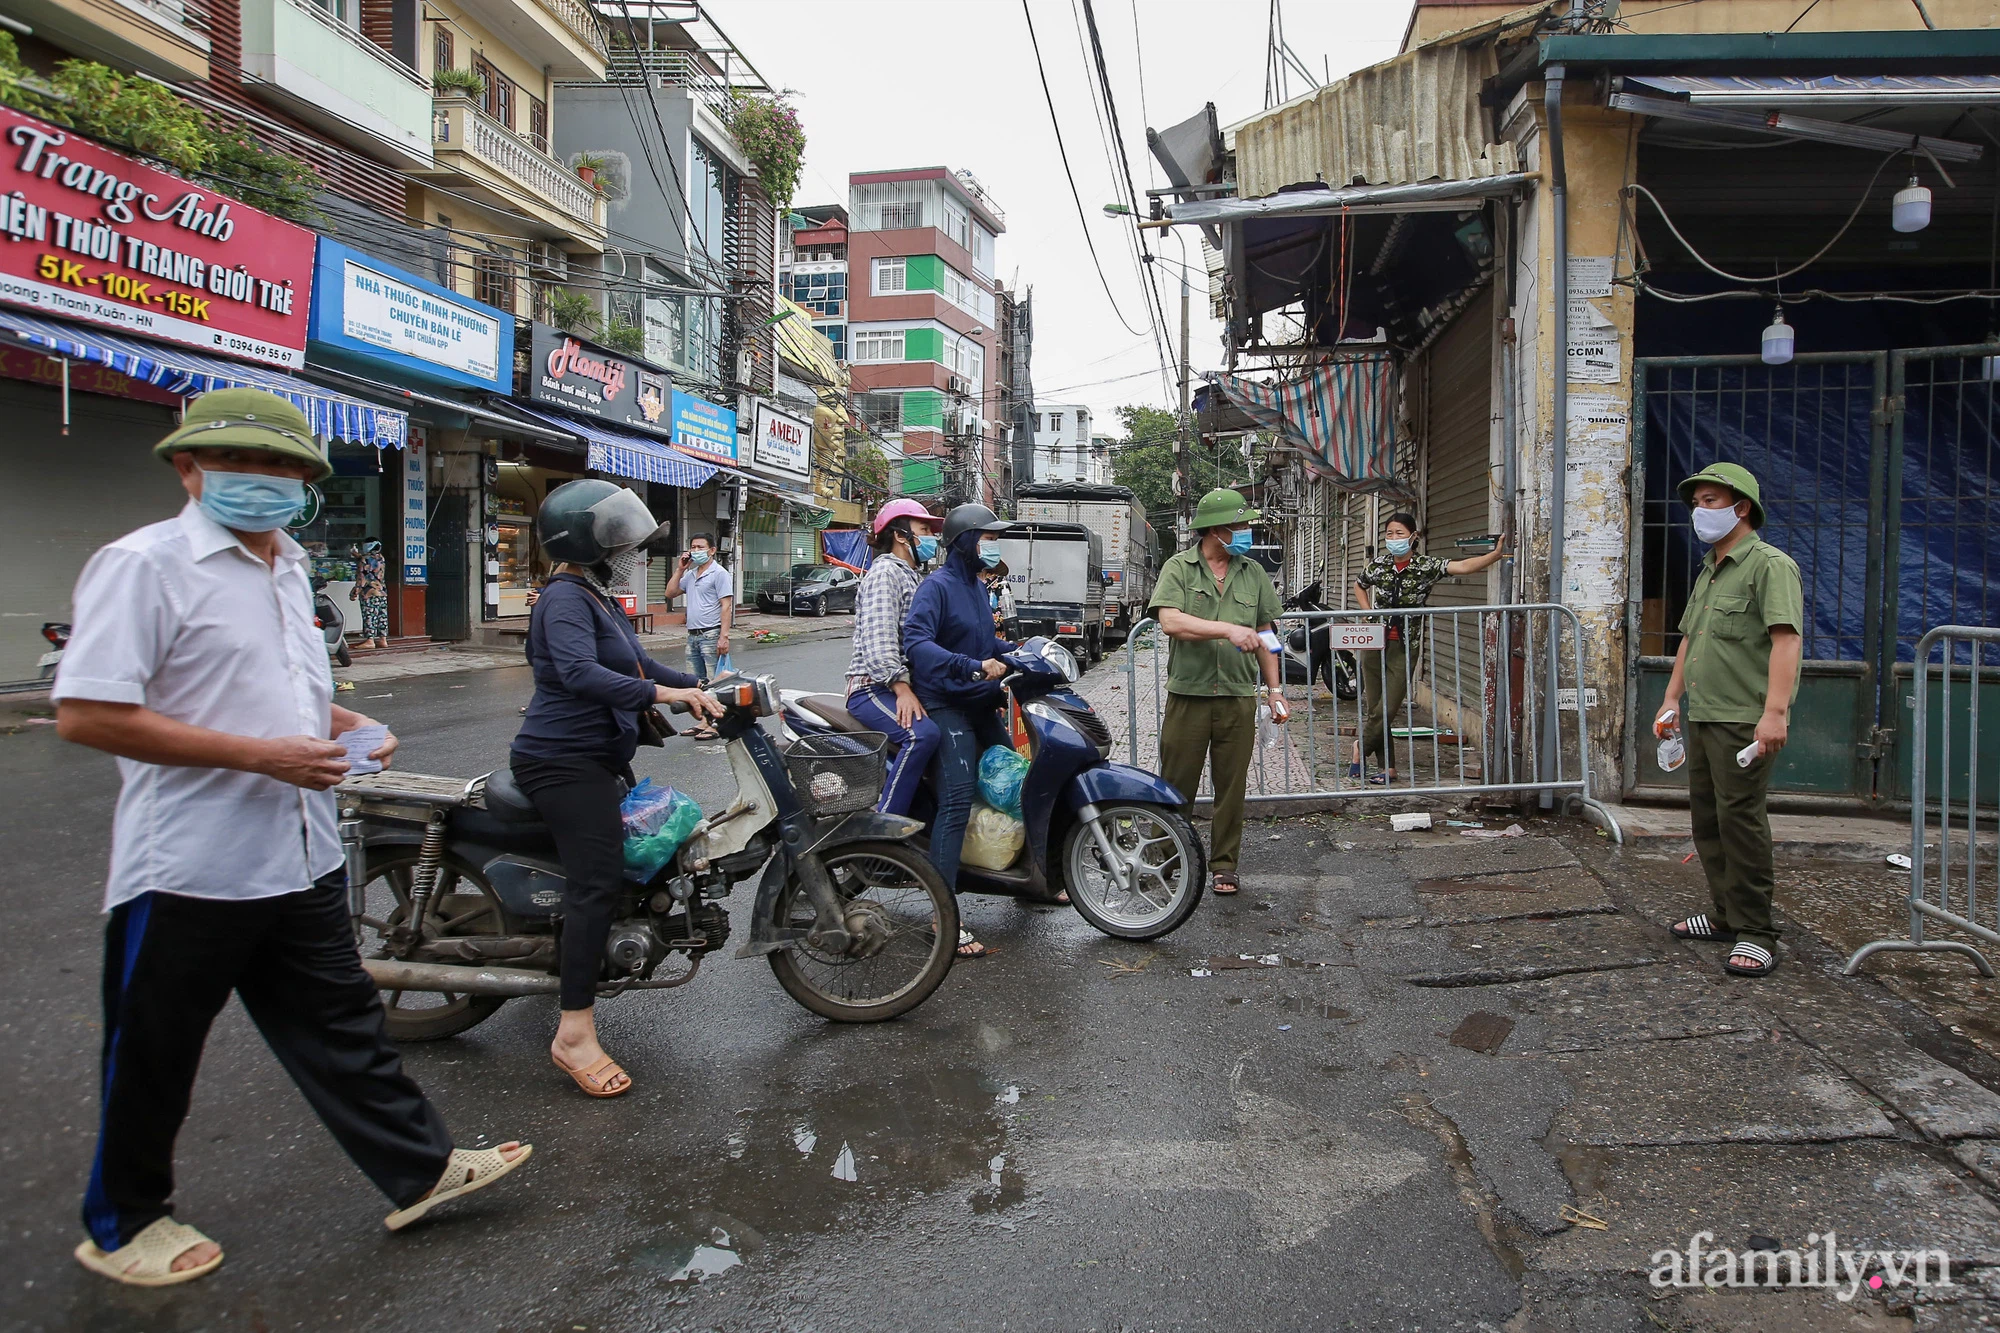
784,636,1208,939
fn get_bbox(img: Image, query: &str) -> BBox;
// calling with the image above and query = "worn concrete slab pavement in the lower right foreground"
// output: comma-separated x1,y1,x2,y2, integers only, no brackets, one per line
1218,815,2000,1333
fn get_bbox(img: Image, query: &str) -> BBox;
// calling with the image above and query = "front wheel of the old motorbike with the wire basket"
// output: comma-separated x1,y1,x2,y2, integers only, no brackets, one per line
770,843,958,1023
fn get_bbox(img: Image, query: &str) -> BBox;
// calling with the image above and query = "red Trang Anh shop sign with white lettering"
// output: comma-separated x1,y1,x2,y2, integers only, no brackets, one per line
0,106,314,366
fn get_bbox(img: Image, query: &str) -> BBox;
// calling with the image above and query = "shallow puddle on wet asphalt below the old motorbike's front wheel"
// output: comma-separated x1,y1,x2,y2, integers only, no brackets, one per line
628,1067,1026,1287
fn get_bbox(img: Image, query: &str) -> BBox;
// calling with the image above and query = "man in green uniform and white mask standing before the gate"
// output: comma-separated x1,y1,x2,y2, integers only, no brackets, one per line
1652,462,1806,977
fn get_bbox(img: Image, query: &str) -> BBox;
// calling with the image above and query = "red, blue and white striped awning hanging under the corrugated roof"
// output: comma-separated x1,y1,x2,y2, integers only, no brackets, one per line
1208,356,1404,492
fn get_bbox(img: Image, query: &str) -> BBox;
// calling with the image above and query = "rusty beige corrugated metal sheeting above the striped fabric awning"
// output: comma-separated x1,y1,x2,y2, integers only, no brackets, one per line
1234,27,1520,198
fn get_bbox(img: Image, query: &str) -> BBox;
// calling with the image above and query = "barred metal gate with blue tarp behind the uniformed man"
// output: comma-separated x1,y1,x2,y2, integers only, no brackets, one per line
1626,346,2000,801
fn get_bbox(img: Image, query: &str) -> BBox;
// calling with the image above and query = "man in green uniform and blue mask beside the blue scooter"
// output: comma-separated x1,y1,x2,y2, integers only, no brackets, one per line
1152,490,1290,893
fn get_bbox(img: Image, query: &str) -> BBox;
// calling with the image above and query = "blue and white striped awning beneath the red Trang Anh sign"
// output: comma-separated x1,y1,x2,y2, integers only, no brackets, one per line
0,310,410,448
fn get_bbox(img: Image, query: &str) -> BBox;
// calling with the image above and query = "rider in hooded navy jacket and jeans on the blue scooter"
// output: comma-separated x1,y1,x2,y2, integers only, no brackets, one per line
902,504,1012,944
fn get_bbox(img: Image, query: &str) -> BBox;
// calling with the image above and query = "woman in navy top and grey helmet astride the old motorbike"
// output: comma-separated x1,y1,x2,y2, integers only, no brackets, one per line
508,478,722,1097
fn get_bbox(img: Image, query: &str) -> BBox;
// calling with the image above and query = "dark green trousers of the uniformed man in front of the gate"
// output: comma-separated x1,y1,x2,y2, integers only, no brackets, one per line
1684,723,1778,949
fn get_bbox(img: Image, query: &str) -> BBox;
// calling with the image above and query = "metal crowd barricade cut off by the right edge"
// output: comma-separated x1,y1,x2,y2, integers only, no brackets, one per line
1840,624,2000,977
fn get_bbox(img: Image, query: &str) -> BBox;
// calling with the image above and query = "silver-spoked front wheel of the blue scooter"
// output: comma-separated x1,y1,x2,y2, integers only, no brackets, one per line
1062,805,1208,939
